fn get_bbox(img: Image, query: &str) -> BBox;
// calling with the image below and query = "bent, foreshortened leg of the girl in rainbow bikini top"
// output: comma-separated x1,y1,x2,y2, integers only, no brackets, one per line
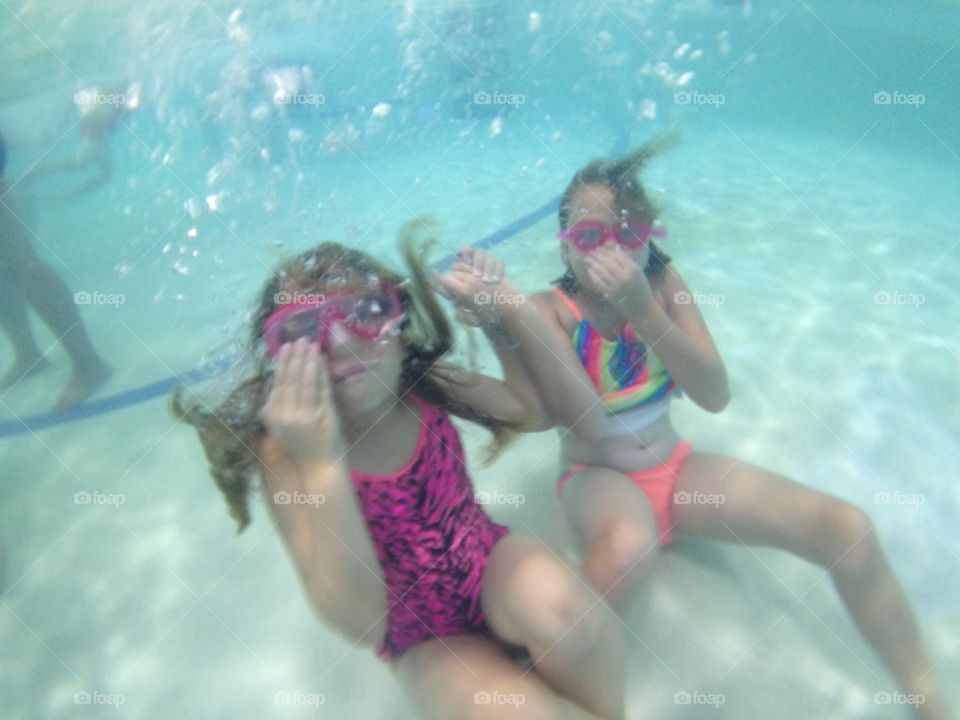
560,467,660,615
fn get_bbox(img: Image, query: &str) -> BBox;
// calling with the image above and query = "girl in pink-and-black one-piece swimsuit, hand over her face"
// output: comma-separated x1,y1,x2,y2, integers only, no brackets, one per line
173,219,626,720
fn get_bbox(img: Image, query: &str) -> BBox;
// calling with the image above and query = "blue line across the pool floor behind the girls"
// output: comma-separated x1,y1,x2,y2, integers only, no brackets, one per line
0,133,627,438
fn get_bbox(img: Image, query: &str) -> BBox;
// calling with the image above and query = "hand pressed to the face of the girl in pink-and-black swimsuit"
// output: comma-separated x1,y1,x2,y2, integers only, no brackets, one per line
260,338,346,466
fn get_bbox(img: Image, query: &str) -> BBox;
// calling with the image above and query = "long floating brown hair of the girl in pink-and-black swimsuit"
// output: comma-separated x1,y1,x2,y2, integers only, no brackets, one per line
171,218,520,533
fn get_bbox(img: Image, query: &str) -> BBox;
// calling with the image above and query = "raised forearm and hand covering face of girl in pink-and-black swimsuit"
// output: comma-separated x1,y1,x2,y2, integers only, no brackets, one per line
261,343,386,641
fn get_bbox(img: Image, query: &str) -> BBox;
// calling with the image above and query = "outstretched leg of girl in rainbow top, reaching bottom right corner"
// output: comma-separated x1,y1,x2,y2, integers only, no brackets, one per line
674,453,947,718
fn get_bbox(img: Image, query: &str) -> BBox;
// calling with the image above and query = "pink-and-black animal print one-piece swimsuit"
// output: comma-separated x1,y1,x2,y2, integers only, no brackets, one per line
350,394,509,660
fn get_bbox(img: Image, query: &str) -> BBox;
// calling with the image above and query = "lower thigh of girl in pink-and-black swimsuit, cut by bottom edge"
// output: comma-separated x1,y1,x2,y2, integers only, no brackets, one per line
396,635,599,720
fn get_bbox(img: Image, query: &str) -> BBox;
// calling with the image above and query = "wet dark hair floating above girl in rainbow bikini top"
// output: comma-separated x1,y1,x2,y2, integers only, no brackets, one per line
553,129,680,295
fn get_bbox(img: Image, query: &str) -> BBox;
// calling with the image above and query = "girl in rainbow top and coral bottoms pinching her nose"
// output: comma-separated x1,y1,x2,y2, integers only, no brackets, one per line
440,135,950,720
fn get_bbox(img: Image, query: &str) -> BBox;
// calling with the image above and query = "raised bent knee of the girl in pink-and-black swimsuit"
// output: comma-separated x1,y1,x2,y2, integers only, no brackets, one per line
481,535,629,720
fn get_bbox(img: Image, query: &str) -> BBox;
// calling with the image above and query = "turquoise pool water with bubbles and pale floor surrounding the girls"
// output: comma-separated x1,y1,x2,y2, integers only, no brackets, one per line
0,0,960,720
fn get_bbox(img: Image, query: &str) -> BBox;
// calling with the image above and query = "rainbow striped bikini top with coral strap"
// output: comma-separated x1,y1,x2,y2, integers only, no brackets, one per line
554,288,677,414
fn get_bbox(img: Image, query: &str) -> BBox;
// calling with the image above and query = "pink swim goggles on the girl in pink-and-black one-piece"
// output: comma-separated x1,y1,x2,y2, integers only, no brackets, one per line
263,282,404,358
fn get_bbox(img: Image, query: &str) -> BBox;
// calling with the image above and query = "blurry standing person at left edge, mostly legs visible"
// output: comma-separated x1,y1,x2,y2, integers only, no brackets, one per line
0,131,112,412
